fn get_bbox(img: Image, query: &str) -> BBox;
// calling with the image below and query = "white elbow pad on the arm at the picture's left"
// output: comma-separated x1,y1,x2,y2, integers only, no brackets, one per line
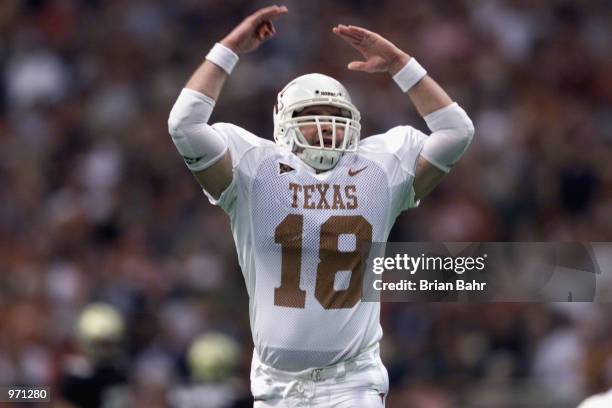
168,88,227,171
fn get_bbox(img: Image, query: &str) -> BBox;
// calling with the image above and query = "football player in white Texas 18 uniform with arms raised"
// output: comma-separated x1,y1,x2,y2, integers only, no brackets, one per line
168,6,474,408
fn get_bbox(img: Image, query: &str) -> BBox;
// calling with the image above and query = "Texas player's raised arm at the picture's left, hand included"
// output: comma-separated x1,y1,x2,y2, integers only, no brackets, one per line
168,6,288,198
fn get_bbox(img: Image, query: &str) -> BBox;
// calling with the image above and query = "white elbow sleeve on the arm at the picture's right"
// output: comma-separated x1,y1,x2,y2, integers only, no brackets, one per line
421,102,474,173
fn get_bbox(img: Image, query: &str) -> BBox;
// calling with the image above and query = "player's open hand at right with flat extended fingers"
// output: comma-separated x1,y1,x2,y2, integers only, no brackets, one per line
332,24,410,75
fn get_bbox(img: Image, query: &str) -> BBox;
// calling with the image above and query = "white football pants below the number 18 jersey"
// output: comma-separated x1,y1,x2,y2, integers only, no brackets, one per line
251,345,389,408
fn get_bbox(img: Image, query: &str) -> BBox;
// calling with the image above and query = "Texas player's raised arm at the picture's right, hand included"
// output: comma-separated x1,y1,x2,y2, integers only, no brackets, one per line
333,25,474,200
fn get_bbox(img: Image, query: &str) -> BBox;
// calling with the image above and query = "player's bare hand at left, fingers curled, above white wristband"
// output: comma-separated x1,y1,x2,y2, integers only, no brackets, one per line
221,6,289,54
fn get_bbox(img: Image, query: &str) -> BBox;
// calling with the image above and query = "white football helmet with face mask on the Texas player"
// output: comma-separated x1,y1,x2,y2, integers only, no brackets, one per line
274,74,361,171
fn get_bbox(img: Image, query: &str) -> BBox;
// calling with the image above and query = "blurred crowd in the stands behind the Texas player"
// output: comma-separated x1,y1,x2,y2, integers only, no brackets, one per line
0,0,612,408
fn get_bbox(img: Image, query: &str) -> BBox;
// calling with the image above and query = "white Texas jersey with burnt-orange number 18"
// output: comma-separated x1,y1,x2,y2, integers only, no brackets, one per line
207,123,426,371
